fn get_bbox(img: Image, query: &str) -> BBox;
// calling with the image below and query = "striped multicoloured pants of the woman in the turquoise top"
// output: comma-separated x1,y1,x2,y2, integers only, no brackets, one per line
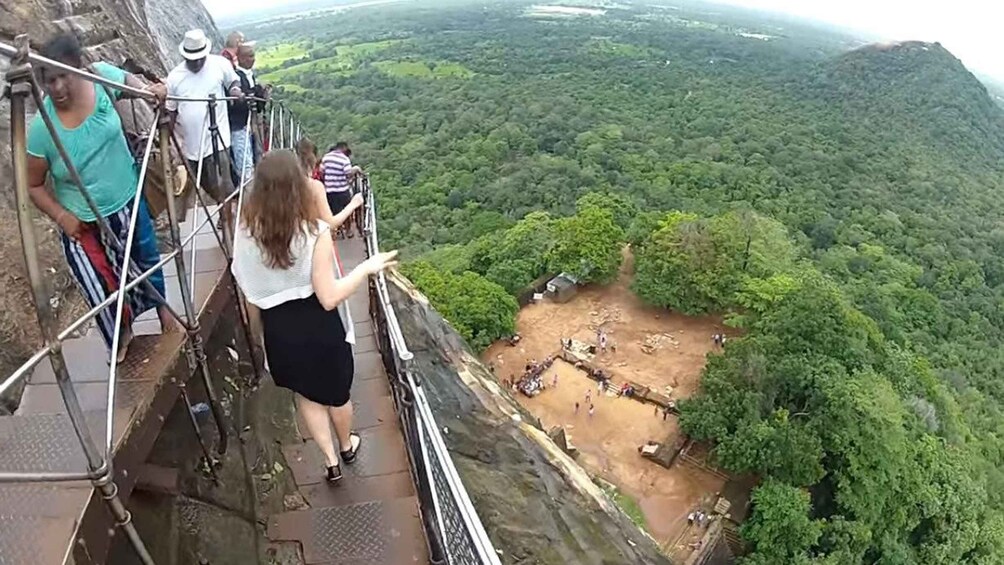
62,200,166,349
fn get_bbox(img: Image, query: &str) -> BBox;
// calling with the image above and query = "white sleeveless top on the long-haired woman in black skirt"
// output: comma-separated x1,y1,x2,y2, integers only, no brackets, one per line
231,220,355,344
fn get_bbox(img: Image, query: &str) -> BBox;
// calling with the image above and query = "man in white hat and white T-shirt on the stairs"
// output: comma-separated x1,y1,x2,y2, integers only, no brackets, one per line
167,29,244,225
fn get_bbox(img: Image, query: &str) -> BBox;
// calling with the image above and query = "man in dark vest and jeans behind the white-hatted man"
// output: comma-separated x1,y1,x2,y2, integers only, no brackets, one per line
229,41,266,186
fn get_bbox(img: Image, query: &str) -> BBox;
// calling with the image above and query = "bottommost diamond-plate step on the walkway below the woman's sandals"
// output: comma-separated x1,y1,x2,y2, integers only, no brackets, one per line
268,497,429,565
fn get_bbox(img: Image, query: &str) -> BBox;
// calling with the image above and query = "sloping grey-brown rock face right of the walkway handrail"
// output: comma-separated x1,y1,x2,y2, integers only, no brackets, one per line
391,270,670,565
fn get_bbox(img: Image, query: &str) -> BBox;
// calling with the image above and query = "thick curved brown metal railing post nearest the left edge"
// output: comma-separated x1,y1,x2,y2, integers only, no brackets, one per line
6,35,154,565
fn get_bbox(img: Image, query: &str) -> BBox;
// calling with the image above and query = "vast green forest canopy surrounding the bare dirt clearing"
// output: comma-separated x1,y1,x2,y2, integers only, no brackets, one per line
248,2,1004,565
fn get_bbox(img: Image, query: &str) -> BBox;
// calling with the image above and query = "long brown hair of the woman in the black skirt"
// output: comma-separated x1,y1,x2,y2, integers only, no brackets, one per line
241,151,317,269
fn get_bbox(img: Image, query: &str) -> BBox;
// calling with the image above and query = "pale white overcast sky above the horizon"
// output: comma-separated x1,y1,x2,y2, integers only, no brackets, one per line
203,0,1004,82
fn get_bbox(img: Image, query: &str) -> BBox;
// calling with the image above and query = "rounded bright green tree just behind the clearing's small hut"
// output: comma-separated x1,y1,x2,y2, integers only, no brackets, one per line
547,206,624,284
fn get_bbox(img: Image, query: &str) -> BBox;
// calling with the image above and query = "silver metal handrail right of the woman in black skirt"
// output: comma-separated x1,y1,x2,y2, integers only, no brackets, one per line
357,176,501,565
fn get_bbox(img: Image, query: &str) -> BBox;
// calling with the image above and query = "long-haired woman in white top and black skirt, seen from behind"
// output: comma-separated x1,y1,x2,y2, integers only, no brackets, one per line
232,151,397,483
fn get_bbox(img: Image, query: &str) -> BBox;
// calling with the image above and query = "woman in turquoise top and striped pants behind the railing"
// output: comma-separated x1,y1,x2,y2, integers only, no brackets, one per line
27,34,175,361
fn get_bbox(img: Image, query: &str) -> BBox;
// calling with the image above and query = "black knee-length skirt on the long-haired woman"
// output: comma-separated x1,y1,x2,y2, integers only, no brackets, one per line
261,294,355,406
